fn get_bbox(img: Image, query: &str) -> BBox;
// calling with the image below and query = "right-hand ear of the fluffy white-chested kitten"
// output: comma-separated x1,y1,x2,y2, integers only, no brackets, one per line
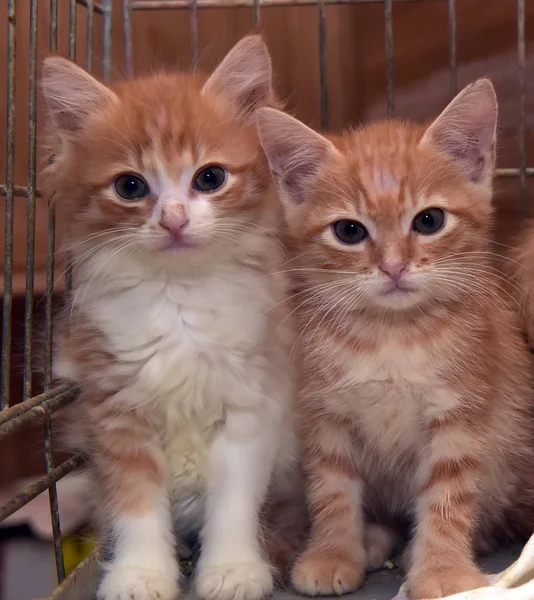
202,35,274,115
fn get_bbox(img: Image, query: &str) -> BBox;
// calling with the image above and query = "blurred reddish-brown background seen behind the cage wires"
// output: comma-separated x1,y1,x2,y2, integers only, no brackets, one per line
0,0,534,482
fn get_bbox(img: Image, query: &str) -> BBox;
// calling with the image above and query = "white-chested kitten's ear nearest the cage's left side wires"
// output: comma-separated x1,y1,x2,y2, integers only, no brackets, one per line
41,56,116,135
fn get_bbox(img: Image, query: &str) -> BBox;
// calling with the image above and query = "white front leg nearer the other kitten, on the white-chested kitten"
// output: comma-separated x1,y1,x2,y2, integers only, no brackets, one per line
196,409,279,600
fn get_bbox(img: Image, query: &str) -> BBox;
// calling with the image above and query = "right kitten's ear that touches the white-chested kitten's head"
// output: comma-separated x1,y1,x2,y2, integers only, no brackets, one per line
256,108,338,204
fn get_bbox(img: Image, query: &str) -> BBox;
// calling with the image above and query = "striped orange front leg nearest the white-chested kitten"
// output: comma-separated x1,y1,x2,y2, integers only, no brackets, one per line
292,414,365,596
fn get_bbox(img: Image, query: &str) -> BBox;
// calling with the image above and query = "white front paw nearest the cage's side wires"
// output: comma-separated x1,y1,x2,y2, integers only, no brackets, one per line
96,565,180,600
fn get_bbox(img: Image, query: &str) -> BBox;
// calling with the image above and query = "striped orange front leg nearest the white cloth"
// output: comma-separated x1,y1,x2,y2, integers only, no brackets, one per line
408,418,487,600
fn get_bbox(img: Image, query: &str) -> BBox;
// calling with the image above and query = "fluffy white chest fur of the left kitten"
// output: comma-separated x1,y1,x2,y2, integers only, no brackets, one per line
58,255,286,520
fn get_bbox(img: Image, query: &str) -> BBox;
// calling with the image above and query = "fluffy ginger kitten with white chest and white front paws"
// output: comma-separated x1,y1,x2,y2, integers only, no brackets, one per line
42,36,302,600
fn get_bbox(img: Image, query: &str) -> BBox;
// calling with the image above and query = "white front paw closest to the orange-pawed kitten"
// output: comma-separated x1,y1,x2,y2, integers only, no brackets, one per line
196,561,273,600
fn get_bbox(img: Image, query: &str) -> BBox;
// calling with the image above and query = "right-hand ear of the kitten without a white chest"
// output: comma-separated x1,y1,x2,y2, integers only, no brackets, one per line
421,79,498,185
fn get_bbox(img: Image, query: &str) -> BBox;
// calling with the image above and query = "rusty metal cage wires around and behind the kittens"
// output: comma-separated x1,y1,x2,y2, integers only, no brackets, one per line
0,0,534,583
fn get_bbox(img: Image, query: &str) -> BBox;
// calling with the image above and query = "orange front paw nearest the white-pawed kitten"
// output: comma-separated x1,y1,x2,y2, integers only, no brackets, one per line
291,553,365,596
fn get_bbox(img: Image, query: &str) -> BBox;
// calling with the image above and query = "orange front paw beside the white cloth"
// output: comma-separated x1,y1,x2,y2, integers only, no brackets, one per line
408,567,488,600
